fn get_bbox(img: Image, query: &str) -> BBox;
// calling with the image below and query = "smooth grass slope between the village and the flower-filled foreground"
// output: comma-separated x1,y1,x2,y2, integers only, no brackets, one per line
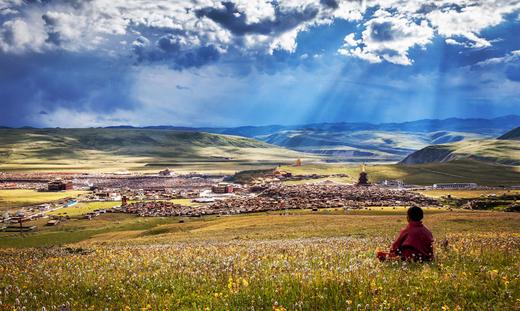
0,208,520,247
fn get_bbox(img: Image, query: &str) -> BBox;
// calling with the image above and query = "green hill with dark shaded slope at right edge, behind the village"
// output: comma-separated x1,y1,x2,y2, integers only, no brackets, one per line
401,139,520,166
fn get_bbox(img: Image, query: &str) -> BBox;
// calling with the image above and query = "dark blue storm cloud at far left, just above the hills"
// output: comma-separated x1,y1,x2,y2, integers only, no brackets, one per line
0,53,136,125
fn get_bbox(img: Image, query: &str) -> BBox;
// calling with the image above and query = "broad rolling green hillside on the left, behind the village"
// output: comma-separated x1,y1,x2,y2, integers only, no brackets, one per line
0,129,310,171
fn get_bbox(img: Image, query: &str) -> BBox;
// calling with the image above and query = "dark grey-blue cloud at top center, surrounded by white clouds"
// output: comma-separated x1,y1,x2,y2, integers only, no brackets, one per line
195,2,319,35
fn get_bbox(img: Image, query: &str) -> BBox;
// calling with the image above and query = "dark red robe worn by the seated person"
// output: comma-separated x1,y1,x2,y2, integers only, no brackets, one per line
390,221,434,261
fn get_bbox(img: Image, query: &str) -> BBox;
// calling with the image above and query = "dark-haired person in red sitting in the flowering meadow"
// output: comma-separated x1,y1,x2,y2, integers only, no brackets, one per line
377,206,433,261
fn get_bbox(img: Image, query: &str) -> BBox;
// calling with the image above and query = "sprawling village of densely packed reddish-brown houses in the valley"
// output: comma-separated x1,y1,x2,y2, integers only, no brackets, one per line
0,160,516,232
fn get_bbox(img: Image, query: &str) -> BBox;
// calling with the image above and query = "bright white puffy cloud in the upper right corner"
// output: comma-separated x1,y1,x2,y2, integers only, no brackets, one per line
338,0,520,65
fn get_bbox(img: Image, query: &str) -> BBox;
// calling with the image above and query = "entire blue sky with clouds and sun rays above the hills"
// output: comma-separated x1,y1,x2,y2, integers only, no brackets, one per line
0,0,520,127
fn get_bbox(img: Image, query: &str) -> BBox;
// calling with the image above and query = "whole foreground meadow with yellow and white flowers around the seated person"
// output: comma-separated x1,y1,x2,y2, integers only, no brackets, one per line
0,209,520,310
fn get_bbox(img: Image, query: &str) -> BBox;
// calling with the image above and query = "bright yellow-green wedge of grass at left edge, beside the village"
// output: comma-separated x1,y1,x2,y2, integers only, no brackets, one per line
0,189,84,211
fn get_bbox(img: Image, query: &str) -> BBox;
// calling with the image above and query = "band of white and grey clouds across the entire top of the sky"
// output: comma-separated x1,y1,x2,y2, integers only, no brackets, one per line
0,0,520,65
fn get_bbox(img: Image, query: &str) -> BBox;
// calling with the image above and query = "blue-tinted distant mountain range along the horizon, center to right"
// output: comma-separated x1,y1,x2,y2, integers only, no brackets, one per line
2,115,520,162
